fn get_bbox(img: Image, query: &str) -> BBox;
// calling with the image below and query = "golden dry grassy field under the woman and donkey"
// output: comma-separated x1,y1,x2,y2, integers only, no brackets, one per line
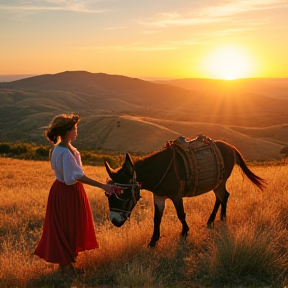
0,158,288,288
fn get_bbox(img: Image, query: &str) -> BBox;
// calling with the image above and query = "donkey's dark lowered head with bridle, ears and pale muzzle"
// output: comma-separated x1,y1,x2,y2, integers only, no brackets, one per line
105,154,141,227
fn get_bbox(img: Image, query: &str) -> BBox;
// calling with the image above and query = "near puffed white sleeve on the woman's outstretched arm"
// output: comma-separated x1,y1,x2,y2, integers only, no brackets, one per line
63,151,84,185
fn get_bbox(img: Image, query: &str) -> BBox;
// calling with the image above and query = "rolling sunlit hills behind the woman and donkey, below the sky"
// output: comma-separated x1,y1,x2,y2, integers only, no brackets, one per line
0,71,288,160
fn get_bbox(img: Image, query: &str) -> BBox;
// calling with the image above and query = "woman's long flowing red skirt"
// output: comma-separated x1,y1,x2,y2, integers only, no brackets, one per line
34,180,98,265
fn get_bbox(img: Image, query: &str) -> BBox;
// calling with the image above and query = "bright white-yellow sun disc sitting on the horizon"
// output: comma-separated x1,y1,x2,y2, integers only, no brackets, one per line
203,46,254,80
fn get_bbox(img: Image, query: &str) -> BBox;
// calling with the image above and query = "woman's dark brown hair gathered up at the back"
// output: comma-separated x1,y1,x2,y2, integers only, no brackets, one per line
44,113,80,145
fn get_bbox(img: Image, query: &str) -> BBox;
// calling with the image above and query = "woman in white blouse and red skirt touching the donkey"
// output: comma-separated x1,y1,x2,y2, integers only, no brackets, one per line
35,114,120,273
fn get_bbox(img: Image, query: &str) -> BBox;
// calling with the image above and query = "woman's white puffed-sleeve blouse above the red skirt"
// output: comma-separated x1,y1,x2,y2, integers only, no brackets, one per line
51,145,84,185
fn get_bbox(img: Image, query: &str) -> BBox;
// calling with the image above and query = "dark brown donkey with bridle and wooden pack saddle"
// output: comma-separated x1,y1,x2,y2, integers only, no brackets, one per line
105,135,266,247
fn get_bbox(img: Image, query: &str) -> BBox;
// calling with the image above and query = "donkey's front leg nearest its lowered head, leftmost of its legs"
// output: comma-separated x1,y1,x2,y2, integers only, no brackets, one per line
148,194,166,247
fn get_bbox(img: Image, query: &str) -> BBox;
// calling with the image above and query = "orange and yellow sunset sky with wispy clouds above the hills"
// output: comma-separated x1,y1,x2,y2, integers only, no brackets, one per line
0,0,288,79
